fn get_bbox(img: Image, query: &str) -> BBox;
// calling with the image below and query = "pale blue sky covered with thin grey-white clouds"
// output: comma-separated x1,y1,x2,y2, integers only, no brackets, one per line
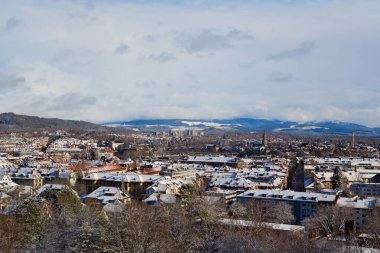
0,0,380,127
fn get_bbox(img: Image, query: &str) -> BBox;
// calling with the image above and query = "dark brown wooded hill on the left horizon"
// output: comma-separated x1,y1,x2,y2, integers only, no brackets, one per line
0,112,107,132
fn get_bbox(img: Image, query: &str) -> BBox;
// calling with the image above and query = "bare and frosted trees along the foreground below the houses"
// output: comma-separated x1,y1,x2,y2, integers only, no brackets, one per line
0,186,380,253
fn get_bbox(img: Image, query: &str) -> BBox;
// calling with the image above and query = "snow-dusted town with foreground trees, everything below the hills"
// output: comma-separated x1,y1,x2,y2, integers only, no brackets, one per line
0,127,380,252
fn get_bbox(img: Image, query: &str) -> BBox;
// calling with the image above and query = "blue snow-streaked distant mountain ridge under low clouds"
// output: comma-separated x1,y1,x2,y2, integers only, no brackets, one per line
103,118,380,136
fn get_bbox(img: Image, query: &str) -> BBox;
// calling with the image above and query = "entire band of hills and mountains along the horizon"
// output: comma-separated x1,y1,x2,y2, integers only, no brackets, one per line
0,112,380,137
